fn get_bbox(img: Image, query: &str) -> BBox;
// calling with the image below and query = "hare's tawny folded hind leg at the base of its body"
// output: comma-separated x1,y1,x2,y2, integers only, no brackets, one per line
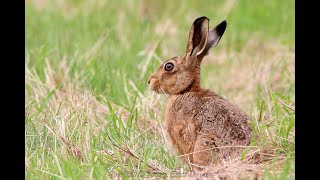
193,136,217,169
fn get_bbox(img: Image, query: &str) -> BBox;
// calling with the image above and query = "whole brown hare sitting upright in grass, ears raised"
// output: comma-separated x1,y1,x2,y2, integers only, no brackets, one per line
148,17,252,169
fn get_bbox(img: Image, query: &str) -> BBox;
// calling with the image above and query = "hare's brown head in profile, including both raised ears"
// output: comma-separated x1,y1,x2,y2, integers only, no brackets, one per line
148,17,227,95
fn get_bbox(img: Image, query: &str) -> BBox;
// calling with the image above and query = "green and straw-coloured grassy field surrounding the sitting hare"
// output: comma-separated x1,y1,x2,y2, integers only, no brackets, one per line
25,0,295,179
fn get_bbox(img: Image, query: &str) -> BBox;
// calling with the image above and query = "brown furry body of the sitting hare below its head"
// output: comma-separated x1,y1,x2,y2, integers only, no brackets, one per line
165,89,251,165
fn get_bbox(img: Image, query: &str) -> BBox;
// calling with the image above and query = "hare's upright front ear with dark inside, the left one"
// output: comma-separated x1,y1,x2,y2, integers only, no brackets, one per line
186,16,209,56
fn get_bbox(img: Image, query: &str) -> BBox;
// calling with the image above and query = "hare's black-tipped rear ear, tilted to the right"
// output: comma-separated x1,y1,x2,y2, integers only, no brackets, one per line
201,20,227,56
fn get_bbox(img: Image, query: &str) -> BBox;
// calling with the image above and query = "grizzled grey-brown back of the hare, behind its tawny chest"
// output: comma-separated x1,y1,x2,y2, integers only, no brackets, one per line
196,91,252,145
